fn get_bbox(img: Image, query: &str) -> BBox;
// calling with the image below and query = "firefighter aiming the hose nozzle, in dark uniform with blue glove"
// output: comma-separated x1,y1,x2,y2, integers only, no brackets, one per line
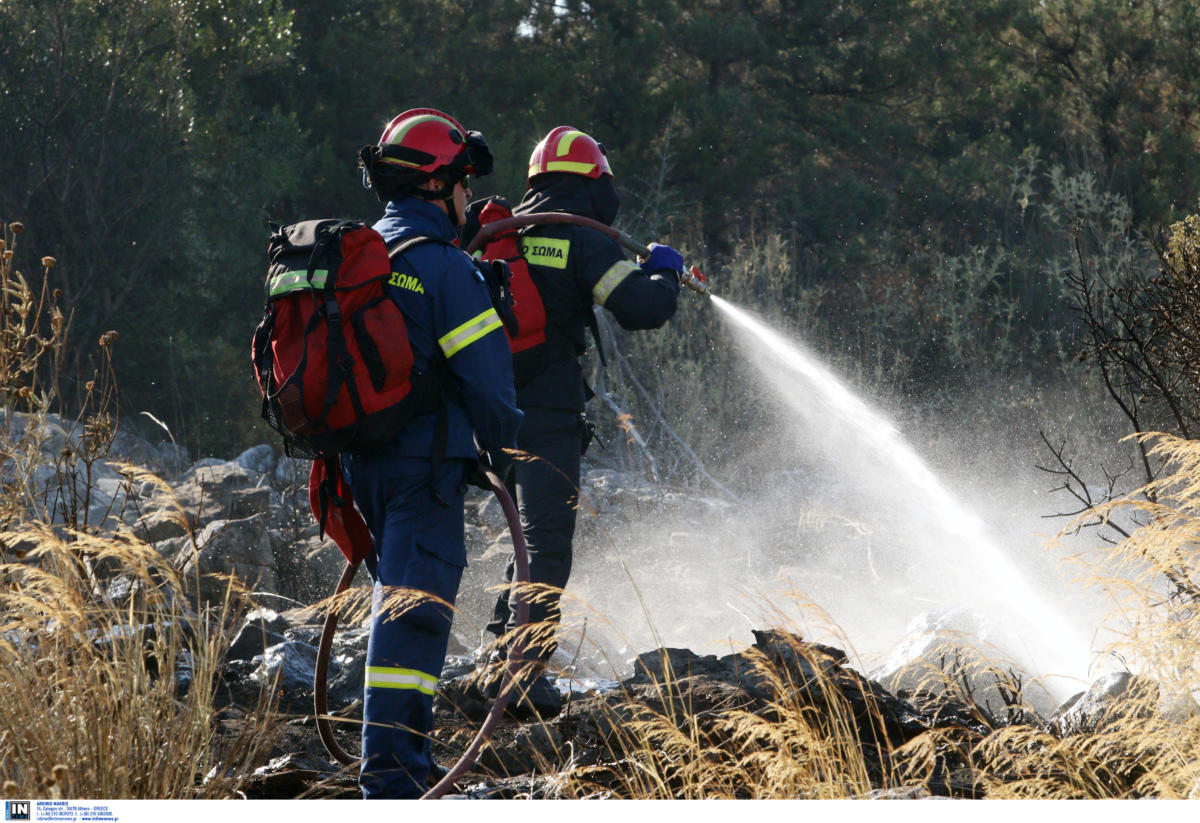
473,126,683,719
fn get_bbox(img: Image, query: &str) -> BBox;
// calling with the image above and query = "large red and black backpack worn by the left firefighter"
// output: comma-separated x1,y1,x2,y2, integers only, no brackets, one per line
251,220,440,457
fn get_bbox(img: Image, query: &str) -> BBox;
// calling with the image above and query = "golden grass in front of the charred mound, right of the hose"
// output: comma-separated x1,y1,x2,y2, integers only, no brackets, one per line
520,623,890,799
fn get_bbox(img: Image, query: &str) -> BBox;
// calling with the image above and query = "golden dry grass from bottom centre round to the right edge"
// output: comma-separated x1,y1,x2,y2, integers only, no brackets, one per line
465,448,1200,799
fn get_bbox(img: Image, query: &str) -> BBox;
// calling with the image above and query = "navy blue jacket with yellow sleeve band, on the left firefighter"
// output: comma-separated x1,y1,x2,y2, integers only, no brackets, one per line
362,197,521,459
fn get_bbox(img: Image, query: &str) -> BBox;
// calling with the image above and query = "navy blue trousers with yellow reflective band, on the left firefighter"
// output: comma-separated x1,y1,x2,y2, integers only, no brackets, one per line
347,455,467,798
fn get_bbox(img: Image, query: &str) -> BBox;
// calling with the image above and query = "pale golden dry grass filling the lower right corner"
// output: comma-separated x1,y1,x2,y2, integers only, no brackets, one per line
997,433,1200,799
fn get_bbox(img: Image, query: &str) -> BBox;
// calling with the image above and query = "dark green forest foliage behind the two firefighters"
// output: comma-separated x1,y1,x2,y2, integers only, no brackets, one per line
0,0,1200,465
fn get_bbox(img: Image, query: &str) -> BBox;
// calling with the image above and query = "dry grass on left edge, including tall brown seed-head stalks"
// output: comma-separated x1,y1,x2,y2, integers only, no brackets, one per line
0,223,272,798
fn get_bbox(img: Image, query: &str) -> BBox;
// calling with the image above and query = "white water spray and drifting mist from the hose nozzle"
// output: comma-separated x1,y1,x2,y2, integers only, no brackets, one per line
552,299,1104,693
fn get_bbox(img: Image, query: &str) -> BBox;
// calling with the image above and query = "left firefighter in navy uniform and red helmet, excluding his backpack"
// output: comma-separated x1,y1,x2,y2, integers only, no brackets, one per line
346,109,521,798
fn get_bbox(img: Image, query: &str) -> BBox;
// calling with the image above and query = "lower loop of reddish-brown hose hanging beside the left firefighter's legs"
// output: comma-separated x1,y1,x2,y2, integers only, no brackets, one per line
313,469,529,800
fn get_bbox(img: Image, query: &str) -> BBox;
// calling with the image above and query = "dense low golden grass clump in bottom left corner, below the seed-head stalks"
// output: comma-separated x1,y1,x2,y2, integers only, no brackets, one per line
0,523,270,798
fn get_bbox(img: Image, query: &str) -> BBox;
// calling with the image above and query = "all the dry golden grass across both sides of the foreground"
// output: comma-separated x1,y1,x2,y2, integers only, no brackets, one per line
9,219,1200,799
